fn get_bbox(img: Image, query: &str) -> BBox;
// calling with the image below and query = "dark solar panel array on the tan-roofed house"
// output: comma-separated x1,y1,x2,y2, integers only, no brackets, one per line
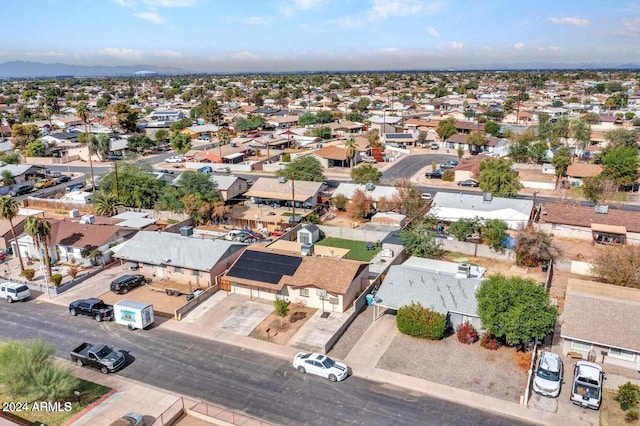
227,250,302,284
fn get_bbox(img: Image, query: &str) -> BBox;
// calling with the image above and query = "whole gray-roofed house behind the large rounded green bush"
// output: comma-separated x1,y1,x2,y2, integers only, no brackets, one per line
373,257,485,330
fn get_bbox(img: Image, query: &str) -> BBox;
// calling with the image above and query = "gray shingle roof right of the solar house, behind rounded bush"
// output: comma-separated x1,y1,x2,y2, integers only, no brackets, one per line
375,265,482,316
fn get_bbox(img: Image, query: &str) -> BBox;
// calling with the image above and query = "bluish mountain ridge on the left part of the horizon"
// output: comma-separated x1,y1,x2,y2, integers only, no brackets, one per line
0,61,193,78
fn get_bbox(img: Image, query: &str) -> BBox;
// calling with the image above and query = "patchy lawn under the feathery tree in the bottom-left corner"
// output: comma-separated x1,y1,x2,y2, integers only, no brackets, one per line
0,379,111,426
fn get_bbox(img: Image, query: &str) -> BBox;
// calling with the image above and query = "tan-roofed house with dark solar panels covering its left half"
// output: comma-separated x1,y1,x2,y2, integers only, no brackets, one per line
220,247,369,312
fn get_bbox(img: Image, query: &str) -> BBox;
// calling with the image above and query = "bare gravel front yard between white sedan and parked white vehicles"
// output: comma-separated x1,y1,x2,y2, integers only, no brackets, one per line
376,335,527,402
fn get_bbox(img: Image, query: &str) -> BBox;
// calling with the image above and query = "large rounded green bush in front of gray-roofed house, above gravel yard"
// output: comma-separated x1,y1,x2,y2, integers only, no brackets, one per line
396,302,447,340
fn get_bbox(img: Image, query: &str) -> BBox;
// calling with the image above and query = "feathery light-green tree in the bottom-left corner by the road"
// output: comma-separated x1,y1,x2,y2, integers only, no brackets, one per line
0,339,79,401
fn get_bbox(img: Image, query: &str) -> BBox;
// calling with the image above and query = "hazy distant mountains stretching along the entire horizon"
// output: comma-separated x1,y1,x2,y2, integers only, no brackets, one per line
0,61,640,78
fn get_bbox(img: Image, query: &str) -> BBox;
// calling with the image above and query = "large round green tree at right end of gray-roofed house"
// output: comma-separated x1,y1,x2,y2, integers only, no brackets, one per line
476,274,558,346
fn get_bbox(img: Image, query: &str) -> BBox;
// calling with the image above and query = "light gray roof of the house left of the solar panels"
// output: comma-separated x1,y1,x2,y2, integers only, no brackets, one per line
115,231,245,271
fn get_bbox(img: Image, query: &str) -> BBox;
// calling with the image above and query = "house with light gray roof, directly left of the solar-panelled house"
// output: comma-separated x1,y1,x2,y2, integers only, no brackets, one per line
114,231,246,287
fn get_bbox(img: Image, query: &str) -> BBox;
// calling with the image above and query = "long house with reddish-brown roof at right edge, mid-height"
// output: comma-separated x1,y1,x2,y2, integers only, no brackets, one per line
537,202,640,244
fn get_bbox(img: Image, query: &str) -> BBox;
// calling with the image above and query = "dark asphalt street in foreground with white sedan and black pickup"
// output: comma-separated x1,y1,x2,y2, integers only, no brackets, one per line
0,300,525,425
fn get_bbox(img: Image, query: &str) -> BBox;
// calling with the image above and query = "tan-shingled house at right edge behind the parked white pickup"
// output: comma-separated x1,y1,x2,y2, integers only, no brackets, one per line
560,278,640,371
